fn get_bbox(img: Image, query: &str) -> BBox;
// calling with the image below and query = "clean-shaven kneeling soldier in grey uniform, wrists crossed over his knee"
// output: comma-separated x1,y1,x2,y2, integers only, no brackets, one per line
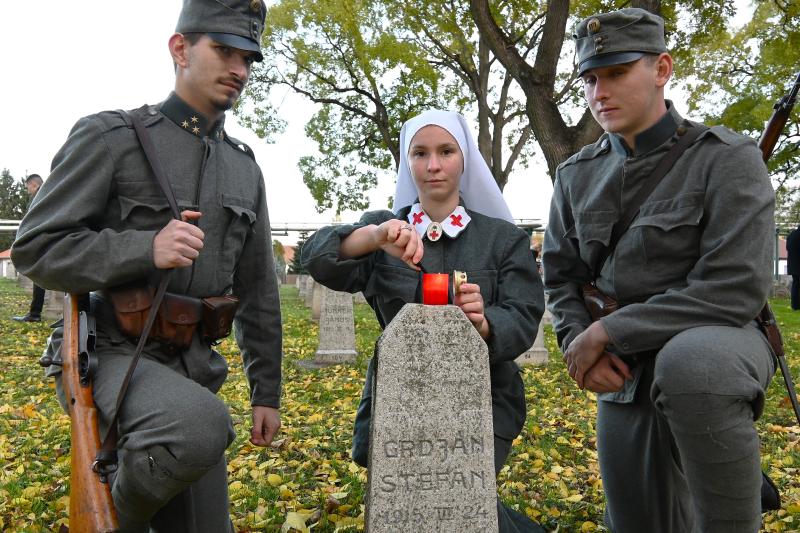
543,9,774,533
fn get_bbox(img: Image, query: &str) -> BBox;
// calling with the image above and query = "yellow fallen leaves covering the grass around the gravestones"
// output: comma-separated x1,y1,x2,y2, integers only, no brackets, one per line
0,280,800,532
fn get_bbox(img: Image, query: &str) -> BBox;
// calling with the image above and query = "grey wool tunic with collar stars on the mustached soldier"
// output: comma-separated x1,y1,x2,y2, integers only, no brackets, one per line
12,94,281,407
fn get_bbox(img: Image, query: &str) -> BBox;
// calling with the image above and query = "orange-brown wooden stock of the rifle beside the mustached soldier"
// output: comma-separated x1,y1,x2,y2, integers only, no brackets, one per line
61,294,119,533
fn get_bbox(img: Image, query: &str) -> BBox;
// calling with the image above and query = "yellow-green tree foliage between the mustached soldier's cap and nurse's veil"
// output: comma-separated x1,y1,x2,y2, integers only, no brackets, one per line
246,0,439,212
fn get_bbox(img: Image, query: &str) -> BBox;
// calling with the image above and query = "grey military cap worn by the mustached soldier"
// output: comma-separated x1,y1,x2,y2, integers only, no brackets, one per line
175,0,267,61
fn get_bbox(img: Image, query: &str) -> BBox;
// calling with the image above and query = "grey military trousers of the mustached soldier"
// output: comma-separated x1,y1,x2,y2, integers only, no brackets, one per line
48,331,235,533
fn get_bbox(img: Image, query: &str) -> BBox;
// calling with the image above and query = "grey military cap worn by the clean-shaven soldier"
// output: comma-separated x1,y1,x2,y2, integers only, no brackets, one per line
572,7,667,75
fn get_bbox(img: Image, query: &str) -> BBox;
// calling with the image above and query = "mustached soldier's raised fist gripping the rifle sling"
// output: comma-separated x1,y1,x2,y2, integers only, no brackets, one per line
153,211,205,269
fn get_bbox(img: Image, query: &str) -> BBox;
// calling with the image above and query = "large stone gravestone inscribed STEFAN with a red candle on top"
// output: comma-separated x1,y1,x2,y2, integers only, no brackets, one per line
366,304,497,533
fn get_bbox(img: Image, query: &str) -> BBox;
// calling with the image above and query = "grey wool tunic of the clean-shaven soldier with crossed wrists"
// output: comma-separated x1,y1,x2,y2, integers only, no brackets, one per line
542,102,774,366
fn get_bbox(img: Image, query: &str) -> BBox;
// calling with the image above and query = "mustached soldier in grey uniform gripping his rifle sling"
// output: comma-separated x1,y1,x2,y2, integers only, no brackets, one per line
12,0,281,533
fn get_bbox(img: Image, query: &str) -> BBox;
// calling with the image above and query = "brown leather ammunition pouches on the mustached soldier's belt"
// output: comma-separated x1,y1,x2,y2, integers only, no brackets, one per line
108,282,239,350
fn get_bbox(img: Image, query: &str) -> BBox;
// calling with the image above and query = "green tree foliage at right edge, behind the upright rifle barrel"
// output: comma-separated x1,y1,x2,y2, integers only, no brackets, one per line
681,0,800,225
